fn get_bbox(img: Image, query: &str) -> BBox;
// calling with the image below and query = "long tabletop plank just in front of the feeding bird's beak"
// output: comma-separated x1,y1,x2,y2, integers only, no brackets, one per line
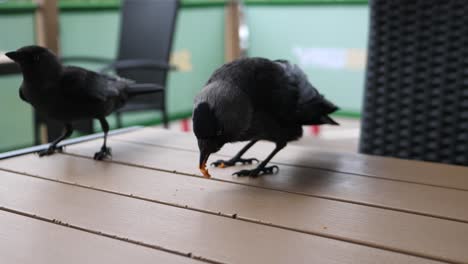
0,155,468,262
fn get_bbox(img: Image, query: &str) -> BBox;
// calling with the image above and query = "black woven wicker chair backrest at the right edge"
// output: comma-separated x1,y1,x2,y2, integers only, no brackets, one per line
360,0,468,165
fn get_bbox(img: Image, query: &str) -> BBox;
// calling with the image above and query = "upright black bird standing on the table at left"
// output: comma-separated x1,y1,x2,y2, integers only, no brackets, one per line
5,46,162,160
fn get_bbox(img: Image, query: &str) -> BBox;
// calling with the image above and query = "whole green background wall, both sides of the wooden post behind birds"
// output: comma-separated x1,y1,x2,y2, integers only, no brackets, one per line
0,0,368,151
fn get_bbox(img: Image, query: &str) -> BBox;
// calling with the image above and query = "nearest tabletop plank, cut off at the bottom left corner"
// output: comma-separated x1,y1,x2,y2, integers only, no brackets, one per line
0,210,197,264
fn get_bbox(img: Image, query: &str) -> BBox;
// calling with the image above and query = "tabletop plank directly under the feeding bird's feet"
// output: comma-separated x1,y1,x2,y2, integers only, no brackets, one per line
59,139,468,223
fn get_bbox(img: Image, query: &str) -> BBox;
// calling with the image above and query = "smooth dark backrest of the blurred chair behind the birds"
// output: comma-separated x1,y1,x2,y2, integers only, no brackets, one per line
117,0,179,106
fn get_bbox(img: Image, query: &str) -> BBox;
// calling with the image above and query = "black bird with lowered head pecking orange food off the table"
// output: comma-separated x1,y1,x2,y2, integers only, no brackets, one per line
193,58,338,177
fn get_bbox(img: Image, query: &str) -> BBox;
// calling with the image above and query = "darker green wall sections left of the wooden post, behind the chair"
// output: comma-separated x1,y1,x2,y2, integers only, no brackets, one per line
0,5,224,151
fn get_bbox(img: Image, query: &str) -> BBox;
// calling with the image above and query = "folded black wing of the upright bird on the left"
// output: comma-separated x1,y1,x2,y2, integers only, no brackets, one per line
60,66,122,102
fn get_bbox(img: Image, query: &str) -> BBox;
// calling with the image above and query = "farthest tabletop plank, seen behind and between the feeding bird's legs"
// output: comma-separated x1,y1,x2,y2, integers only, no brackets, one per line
113,128,468,190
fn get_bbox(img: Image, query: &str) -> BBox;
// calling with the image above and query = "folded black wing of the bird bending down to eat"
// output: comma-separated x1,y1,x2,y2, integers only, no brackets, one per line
208,58,337,124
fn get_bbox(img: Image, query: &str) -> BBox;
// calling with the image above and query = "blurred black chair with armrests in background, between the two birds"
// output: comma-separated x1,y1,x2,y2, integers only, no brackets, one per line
35,0,180,143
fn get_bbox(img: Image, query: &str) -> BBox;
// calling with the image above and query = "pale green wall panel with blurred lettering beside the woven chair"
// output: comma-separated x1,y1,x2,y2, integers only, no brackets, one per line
247,5,368,114
